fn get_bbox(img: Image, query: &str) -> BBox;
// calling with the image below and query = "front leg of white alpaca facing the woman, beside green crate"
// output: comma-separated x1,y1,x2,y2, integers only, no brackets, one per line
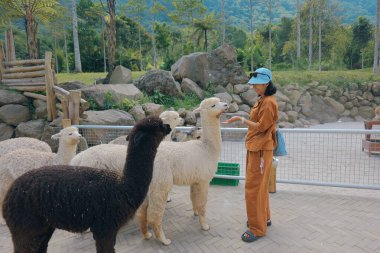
194,182,210,230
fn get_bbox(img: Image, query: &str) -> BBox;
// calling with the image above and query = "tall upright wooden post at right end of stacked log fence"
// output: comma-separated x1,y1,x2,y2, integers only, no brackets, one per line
45,52,57,121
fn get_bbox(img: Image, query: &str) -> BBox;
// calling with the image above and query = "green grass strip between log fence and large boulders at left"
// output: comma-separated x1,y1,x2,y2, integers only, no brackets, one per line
57,71,146,85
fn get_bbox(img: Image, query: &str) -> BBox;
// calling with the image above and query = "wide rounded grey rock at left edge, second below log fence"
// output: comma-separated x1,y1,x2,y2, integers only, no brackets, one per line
0,104,32,126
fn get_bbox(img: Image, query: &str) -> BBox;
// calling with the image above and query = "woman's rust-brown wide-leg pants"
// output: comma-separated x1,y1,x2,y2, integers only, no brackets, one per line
245,150,273,236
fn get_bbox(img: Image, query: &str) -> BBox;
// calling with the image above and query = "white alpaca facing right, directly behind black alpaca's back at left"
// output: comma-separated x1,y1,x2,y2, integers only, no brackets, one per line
0,127,81,224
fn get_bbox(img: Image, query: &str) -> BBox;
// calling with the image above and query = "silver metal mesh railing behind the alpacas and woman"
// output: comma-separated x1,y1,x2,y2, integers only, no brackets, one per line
74,125,380,189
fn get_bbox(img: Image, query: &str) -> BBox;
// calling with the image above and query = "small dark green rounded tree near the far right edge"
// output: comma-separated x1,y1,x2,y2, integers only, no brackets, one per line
352,17,372,68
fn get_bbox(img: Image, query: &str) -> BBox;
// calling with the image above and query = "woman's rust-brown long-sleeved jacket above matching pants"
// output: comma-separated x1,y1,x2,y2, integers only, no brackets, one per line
245,96,278,151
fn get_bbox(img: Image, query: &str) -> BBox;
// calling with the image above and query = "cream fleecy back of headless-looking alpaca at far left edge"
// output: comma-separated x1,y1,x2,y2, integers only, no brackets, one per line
0,137,52,157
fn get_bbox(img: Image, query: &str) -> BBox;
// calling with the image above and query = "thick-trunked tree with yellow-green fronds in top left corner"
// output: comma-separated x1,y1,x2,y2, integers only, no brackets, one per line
3,0,58,59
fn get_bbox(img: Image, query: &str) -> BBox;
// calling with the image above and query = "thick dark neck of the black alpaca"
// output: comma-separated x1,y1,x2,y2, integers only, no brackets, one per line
121,141,158,209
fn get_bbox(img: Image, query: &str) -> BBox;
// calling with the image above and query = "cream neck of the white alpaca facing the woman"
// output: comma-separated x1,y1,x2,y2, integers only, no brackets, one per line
201,112,222,154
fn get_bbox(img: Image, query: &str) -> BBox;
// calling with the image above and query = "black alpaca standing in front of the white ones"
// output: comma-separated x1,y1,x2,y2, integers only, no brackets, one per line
3,117,171,253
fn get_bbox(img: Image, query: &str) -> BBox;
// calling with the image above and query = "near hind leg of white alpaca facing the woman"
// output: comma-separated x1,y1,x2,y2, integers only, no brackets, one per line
148,190,171,245
